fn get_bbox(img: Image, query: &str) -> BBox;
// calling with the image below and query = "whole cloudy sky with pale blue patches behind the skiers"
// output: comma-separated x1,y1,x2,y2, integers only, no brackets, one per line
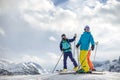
0,0,120,68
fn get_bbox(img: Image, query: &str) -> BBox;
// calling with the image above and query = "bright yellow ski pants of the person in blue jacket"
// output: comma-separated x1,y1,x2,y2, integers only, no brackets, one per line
79,50,89,72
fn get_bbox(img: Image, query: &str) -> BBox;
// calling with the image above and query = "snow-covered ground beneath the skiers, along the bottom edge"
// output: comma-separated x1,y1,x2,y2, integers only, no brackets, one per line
0,72,120,80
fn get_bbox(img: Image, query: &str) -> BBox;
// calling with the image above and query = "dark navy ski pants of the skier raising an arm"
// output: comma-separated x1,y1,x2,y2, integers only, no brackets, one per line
63,52,78,69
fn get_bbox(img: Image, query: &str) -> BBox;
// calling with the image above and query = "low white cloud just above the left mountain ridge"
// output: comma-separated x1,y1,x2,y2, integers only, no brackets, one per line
20,52,59,69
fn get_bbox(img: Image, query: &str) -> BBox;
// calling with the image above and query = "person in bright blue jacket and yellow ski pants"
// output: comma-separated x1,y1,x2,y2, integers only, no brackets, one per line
76,25,95,73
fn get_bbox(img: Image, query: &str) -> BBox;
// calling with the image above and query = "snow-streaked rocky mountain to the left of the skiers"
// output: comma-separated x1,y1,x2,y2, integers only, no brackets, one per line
0,60,45,75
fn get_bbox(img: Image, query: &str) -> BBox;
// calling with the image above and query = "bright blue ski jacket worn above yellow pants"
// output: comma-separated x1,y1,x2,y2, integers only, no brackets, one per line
77,32,95,50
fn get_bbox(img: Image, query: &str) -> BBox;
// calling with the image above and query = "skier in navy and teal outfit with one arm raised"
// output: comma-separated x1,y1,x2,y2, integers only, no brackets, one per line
60,34,78,72
